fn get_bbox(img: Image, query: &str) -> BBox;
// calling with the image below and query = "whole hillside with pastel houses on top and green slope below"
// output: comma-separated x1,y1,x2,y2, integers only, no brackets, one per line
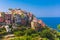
0,8,60,40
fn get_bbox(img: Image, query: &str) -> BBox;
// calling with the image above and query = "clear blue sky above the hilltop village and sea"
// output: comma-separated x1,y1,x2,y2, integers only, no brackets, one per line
0,0,60,17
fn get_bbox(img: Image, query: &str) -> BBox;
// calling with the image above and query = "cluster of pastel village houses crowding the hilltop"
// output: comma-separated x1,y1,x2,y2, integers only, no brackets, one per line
0,9,46,32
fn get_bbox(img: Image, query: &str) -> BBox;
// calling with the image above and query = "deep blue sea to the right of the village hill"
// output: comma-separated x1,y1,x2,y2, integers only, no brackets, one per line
38,17,60,29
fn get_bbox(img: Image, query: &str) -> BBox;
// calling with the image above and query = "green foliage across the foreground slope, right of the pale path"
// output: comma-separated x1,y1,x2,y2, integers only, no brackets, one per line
11,27,60,40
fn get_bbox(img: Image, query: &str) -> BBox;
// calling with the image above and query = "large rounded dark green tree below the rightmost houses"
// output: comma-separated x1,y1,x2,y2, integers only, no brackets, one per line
40,29,55,40
